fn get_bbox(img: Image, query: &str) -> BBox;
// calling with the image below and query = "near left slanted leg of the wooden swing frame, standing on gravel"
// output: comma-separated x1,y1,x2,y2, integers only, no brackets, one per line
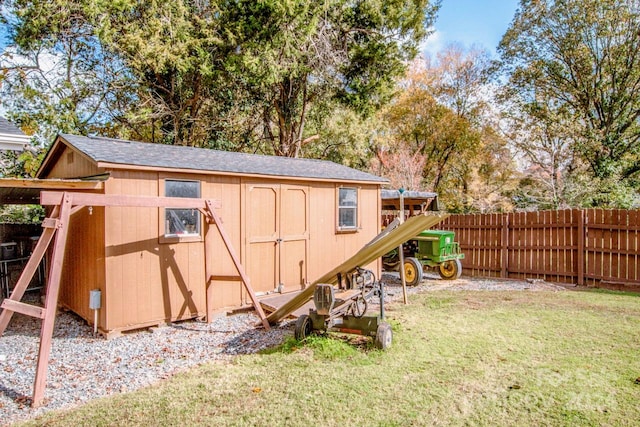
32,193,71,408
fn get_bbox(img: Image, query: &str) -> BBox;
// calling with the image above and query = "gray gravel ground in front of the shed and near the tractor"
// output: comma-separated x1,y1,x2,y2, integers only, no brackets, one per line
0,273,564,426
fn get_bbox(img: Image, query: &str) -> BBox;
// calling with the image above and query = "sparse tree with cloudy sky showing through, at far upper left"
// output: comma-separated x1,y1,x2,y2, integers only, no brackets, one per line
0,0,126,142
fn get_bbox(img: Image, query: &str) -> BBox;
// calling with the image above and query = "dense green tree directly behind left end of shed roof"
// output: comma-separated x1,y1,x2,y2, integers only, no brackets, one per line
95,0,235,148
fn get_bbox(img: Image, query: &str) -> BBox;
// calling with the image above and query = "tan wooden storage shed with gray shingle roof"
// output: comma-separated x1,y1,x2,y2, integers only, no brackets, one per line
37,135,386,333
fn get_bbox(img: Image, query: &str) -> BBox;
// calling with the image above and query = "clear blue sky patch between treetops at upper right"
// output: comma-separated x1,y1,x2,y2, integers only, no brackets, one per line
423,0,520,55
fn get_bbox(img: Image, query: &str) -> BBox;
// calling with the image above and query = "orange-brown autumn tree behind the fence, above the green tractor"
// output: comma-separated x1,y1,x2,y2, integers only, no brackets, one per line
374,46,513,211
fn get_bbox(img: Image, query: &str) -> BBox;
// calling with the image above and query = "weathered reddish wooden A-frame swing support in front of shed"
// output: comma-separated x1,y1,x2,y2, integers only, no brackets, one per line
0,191,269,407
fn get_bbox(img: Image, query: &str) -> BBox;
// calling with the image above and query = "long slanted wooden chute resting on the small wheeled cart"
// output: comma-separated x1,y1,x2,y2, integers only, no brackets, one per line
267,212,449,325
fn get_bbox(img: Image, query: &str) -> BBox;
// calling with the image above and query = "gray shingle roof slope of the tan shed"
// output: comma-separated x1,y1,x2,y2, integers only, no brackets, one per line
60,134,387,183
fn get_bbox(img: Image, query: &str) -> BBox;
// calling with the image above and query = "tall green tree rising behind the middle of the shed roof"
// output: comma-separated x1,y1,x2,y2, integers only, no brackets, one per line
228,0,439,157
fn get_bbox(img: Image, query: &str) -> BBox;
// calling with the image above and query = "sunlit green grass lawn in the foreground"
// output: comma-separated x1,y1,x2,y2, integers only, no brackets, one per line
17,291,640,426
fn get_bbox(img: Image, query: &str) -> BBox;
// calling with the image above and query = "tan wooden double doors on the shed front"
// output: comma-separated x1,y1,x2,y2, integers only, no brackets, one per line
244,183,309,292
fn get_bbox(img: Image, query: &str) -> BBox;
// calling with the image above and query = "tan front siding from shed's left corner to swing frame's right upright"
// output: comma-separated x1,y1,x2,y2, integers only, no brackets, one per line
105,171,207,330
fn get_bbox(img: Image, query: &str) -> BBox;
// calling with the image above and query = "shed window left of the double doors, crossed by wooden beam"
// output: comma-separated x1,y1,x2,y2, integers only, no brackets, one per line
164,179,200,237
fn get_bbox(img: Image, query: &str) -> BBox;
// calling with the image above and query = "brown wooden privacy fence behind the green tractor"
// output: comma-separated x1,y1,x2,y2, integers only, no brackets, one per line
439,209,640,287
